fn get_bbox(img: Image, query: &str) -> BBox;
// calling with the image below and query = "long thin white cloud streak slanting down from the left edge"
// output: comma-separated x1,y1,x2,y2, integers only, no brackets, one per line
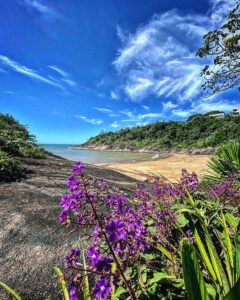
0,55,64,89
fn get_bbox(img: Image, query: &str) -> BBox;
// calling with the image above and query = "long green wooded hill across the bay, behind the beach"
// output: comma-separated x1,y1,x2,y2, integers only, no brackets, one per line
83,113,240,150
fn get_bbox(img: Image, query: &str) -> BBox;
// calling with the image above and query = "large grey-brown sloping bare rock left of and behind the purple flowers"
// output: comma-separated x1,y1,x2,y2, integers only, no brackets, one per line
0,156,136,300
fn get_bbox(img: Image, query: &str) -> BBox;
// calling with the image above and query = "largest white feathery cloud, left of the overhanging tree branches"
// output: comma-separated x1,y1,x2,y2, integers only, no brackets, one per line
114,0,234,102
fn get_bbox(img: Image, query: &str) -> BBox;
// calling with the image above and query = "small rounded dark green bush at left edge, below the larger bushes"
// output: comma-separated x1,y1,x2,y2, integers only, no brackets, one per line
0,150,24,181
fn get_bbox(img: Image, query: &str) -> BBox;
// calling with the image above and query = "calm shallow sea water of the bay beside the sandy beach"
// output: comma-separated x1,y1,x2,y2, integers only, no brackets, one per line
43,144,156,165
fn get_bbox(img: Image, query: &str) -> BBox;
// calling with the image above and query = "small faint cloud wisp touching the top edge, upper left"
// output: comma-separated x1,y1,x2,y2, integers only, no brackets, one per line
18,0,60,18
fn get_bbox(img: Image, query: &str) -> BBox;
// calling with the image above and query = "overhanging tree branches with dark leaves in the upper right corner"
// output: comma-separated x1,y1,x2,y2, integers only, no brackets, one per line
197,1,240,96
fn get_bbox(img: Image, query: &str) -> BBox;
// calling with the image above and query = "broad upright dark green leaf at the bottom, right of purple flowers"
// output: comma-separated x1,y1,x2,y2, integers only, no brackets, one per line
182,238,209,300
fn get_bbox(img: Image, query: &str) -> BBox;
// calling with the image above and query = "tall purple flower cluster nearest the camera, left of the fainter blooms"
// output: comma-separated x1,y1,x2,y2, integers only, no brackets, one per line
59,162,149,299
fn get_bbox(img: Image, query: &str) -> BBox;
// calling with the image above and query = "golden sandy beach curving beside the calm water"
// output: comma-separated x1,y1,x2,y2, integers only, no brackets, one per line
104,154,210,182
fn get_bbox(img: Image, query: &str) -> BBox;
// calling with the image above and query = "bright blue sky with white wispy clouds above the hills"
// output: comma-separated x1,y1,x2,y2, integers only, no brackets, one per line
0,0,240,144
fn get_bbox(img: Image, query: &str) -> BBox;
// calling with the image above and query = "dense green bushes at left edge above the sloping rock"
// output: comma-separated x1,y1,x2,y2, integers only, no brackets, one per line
0,114,45,181
